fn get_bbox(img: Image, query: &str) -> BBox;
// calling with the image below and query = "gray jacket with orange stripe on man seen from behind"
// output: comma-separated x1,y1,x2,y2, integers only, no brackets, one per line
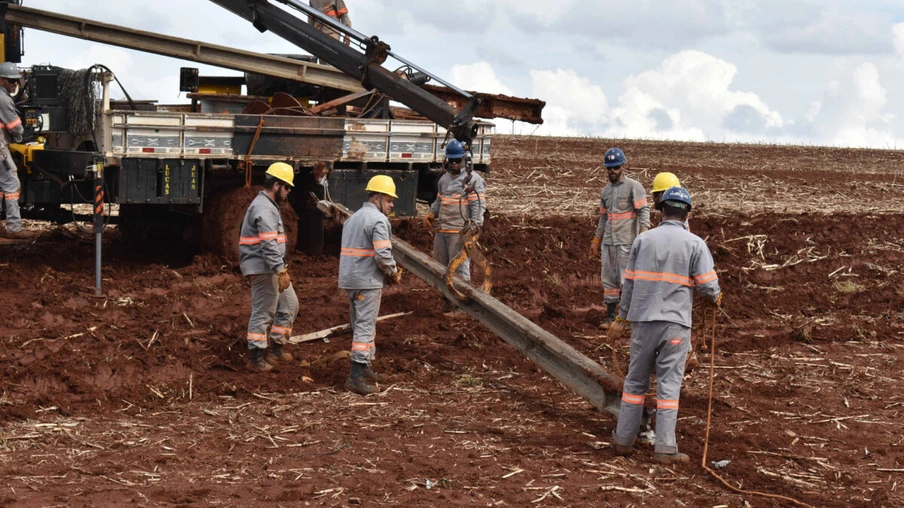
619,220,720,327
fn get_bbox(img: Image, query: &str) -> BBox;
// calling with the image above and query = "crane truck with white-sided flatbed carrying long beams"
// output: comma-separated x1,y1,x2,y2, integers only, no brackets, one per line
0,0,544,256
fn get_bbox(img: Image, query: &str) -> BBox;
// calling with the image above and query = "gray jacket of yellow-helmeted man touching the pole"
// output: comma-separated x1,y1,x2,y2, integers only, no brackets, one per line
339,201,396,289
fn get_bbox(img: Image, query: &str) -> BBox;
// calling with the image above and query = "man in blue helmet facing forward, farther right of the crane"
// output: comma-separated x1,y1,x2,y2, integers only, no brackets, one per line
590,148,650,329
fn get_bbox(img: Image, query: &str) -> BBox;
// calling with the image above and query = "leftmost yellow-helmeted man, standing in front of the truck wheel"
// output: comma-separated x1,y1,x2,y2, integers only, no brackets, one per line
239,162,298,371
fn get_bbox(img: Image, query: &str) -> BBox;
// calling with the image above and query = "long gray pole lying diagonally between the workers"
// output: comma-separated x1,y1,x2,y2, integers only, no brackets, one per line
318,201,621,418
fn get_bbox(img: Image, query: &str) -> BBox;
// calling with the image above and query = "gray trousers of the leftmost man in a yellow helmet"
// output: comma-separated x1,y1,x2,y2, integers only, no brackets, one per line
248,273,298,349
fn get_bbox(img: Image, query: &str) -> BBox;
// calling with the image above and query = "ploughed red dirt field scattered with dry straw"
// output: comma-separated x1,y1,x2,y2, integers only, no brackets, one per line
0,136,904,507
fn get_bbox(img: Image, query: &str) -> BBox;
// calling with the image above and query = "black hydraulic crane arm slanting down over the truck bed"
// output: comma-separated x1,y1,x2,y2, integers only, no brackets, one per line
210,0,479,143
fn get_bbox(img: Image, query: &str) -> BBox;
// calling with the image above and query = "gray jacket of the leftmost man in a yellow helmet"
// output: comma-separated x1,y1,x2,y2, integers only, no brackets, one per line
239,191,286,276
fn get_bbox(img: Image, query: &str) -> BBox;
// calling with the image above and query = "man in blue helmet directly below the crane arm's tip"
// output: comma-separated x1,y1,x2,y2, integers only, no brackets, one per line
424,139,487,311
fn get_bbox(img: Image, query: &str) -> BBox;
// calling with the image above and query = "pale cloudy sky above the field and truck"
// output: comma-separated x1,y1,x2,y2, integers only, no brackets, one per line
17,0,904,149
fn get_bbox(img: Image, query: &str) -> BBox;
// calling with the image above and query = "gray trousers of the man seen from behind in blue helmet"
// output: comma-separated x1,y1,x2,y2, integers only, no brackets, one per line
613,321,691,453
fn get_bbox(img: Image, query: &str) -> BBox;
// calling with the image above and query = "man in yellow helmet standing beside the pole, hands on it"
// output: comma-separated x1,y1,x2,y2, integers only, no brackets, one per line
339,175,402,395
